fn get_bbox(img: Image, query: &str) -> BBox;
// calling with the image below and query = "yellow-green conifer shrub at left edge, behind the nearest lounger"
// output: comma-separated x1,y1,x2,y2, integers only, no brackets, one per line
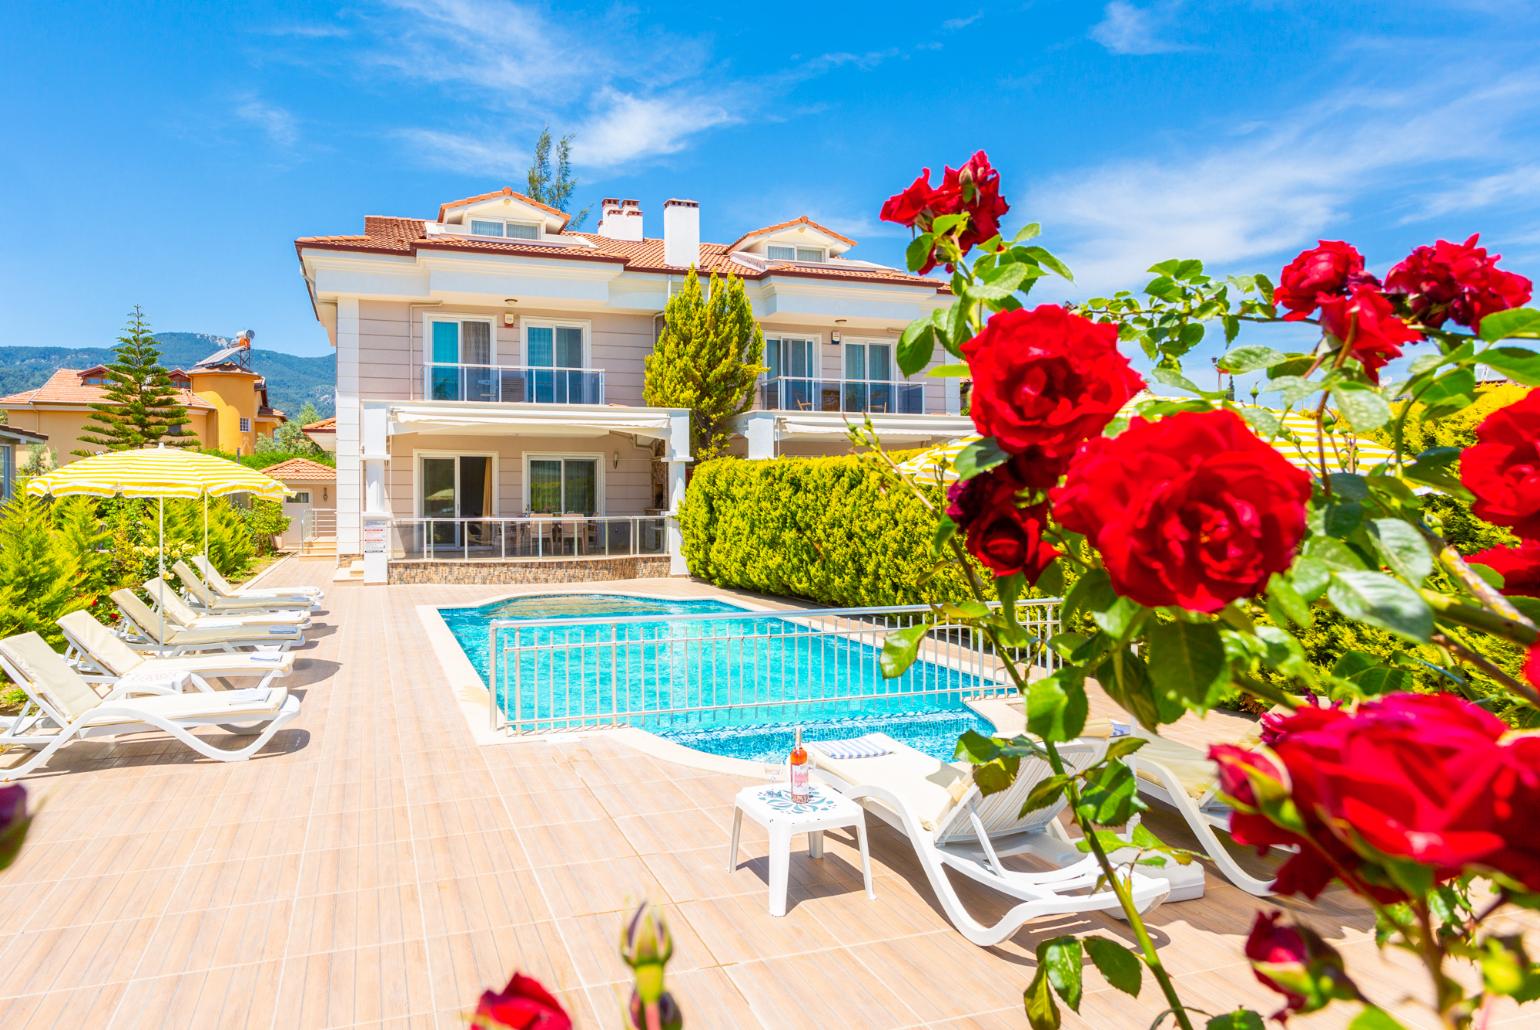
0,490,85,645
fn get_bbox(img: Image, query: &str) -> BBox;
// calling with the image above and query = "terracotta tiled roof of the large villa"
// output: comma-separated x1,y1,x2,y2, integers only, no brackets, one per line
294,218,949,293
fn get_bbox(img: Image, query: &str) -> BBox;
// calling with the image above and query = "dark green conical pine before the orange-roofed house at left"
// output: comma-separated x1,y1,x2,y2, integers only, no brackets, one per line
74,305,197,457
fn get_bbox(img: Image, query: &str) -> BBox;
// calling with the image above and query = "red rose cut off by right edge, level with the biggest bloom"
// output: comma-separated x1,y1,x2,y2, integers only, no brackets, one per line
1460,390,1540,539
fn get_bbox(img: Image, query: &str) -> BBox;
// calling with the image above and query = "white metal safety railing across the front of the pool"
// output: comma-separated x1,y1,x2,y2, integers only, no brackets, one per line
486,599,1060,733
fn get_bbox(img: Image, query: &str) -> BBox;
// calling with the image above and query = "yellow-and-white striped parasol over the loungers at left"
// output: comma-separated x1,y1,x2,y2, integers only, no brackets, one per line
26,443,290,639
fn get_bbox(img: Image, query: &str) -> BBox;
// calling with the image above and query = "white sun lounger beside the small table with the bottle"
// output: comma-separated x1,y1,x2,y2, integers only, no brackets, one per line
809,734,1170,947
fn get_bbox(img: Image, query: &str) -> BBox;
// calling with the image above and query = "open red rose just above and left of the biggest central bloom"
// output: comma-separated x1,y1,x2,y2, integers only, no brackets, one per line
963,303,1144,468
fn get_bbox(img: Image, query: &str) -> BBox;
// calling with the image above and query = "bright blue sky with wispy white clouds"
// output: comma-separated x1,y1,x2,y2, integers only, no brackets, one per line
0,0,1540,360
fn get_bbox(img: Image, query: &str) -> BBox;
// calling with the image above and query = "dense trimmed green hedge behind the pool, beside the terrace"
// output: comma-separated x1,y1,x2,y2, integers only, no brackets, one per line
679,454,970,607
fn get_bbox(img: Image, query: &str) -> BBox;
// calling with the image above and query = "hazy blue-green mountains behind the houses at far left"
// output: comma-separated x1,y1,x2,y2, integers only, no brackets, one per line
0,333,337,417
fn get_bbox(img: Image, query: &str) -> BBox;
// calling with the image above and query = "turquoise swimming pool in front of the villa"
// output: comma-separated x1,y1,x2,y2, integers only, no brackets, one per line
439,594,996,761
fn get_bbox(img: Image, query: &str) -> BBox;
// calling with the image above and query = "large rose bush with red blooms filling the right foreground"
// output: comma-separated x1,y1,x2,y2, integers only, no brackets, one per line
867,152,1540,1028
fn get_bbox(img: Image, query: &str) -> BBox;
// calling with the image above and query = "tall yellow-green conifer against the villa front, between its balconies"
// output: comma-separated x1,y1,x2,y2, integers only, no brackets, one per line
642,268,765,462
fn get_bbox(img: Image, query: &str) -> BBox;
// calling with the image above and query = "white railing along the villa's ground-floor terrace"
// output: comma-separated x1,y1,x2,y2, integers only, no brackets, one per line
391,516,668,562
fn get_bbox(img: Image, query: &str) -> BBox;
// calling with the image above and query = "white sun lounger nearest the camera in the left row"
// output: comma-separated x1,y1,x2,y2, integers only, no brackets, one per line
0,633,299,781
